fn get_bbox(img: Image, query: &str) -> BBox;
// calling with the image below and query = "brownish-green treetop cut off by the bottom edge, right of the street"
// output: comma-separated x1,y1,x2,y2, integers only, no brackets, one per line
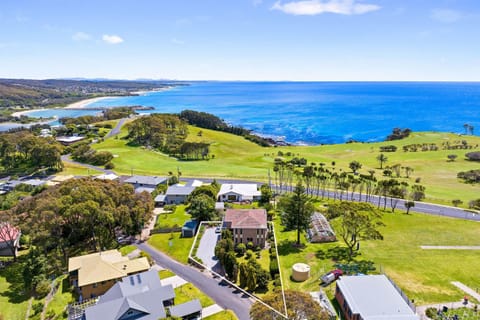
250,290,329,320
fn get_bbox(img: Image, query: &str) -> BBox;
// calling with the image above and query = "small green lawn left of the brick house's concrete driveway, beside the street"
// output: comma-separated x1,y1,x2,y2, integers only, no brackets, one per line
148,232,194,263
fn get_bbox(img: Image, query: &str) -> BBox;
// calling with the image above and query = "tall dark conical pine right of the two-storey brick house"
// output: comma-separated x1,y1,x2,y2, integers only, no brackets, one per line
279,181,315,245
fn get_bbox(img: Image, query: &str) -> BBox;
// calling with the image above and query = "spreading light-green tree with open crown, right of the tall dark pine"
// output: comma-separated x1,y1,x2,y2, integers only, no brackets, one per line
328,201,385,260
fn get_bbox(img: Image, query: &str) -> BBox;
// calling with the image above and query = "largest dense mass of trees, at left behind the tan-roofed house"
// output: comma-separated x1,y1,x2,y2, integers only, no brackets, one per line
4,178,154,262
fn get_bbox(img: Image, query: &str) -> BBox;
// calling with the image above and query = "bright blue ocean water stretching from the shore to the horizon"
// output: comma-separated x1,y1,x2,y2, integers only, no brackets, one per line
17,82,480,144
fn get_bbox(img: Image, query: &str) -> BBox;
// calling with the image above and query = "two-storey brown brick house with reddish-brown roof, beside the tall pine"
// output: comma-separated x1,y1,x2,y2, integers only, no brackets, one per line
223,209,268,248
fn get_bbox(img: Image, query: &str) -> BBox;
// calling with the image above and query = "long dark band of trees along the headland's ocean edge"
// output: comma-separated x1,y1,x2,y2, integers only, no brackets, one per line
180,110,272,147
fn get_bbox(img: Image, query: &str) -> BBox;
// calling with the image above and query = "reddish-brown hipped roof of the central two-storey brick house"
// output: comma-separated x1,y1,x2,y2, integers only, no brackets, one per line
223,209,267,229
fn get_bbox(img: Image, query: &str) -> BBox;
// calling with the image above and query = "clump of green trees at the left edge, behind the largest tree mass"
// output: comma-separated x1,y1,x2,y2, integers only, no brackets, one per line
0,130,63,174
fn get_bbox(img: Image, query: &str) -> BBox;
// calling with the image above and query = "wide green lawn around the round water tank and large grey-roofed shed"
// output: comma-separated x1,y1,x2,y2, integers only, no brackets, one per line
275,208,480,305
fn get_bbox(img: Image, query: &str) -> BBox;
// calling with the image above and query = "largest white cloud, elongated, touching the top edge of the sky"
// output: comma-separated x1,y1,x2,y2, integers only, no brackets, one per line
271,0,381,16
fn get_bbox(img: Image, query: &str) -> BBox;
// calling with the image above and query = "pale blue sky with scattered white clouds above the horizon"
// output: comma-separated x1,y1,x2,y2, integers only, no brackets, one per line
0,0,480,81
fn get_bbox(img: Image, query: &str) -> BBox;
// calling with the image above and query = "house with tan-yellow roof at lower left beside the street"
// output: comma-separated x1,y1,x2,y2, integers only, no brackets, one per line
68,250,150,301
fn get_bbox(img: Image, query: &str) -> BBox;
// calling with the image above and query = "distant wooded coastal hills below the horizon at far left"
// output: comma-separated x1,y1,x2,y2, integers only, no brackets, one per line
0,79,180,110
